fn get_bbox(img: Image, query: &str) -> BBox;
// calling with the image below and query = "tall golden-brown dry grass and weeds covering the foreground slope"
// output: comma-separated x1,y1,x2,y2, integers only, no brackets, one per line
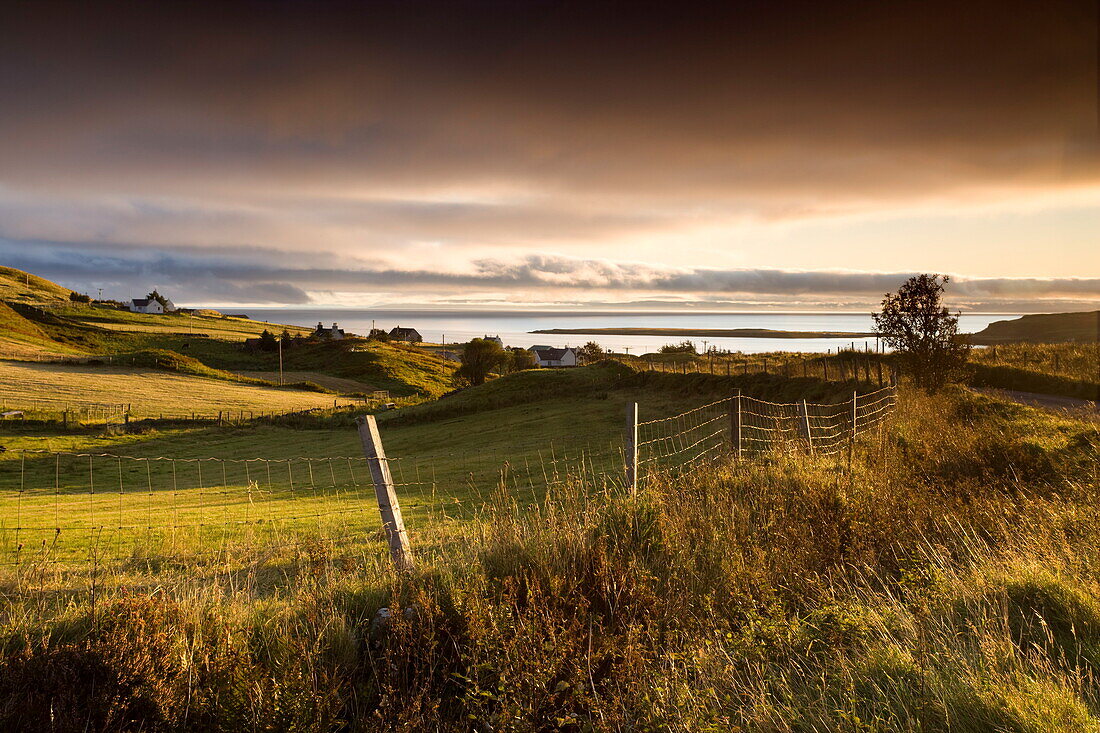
0,392,1100,731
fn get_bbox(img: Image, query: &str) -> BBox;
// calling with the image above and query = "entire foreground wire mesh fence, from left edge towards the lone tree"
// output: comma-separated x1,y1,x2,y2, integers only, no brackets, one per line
0,386,897,592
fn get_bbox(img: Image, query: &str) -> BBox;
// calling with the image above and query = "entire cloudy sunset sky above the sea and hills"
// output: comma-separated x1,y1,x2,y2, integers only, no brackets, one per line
0,0,1100,313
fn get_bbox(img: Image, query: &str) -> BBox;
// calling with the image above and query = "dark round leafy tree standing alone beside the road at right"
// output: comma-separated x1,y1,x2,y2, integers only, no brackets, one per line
871,274,970,392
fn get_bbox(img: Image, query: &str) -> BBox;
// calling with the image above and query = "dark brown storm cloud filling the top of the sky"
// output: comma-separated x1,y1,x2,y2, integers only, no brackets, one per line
0,0,1096,204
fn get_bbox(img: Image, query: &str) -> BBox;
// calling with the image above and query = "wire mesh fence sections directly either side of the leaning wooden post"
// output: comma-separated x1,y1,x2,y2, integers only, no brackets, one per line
0,437,623,570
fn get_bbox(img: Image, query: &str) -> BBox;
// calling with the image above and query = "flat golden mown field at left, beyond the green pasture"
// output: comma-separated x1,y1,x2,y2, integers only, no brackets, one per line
0,361,352,417
